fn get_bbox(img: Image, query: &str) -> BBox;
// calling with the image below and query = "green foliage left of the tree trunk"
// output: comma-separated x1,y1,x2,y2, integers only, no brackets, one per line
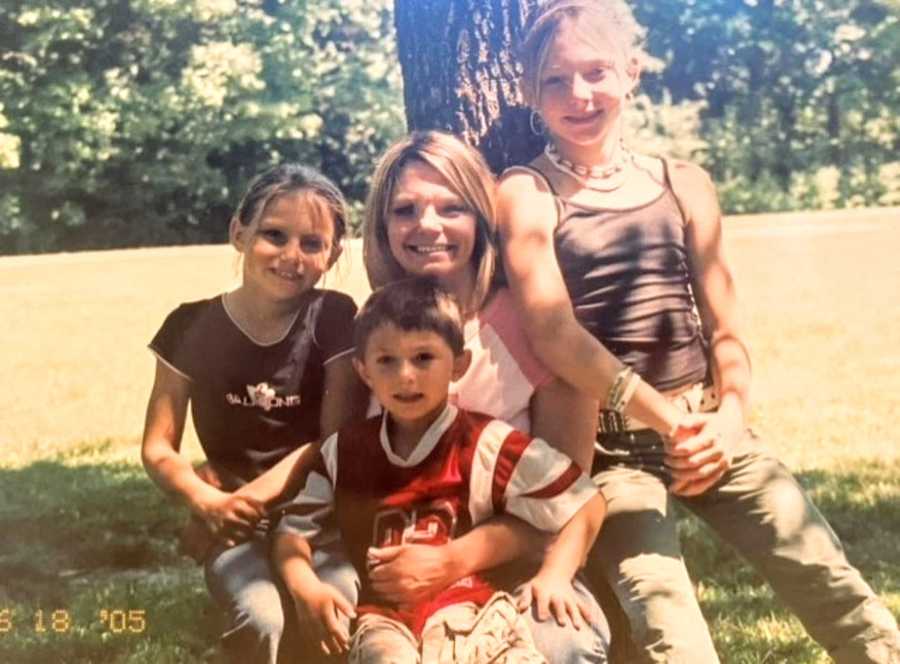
0,0,403,252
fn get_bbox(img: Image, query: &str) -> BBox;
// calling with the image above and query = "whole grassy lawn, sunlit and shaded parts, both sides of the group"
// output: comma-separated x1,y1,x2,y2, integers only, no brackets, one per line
0,210,900,664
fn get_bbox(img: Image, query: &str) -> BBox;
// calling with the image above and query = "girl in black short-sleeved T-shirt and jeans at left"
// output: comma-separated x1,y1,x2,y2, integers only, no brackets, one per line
141,164,367,664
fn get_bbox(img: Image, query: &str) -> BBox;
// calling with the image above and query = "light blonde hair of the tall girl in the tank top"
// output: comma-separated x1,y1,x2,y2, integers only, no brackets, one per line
519,0,646,106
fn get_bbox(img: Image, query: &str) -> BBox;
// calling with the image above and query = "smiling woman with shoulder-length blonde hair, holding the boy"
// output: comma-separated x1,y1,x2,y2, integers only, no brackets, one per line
363,131,607,664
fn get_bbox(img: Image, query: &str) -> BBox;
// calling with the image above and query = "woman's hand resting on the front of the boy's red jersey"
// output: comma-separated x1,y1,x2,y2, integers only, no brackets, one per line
366,544,458,605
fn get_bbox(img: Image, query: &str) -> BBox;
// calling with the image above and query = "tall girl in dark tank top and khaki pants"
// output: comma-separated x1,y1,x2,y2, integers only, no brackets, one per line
499,0,900,664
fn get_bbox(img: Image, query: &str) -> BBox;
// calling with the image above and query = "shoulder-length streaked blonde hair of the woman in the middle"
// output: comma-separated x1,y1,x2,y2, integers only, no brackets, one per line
363,131,502,314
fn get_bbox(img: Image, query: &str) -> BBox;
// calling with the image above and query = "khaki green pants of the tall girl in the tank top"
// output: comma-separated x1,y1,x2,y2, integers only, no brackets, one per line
589,431,900,664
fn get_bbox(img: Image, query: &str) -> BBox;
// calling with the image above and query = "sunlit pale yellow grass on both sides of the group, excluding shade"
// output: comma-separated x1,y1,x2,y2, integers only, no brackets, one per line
0,209,900,467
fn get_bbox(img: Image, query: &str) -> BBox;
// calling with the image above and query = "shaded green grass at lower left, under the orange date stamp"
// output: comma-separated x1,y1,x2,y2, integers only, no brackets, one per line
0,442,217,663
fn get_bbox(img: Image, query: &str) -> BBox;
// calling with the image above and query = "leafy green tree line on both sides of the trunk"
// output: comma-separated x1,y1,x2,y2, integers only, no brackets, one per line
0,0,900,253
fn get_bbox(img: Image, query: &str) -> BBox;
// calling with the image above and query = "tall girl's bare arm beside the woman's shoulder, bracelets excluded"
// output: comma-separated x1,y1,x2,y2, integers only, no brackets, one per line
498,173,681,434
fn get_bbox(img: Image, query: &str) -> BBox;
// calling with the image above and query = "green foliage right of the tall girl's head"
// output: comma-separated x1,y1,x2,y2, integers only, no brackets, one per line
635,0,900,212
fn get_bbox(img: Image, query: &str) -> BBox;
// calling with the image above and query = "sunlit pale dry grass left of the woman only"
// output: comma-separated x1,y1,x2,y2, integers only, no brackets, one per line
0,241,369,464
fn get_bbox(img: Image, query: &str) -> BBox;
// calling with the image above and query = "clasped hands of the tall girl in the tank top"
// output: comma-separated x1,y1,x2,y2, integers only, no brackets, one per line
666,408,744,496
